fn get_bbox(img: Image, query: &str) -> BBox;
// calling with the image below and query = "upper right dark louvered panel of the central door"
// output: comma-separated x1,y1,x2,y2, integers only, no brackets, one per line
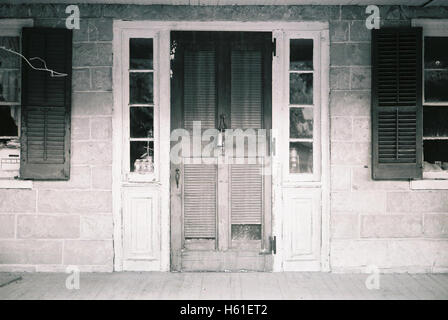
230,50,263,129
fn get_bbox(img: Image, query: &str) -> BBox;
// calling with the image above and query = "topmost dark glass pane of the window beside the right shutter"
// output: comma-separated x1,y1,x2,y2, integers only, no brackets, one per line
425,37,448,69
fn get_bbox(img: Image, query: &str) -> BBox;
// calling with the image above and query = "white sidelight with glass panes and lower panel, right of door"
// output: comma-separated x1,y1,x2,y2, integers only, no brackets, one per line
273,31,328,271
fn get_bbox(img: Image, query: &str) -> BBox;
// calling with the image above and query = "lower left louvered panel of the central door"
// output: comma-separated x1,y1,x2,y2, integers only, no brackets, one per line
183,164,217,239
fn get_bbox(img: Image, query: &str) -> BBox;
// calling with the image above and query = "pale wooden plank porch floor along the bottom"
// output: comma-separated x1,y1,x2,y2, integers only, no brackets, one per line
0,272,448,300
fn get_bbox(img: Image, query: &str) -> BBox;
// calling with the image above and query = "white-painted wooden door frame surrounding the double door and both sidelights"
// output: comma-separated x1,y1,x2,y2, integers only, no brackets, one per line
112,20,330,271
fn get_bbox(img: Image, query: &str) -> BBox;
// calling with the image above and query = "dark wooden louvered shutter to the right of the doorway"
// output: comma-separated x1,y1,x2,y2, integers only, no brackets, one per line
372,28,423,180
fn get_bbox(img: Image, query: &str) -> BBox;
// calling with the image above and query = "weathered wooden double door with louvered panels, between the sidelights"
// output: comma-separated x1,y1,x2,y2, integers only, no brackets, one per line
170,32,275,271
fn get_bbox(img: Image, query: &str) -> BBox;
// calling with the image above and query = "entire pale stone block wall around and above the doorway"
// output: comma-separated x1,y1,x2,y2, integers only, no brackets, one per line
0,4,448,272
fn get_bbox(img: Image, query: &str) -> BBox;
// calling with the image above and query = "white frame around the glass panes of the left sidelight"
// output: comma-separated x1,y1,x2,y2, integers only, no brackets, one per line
121,29,160,182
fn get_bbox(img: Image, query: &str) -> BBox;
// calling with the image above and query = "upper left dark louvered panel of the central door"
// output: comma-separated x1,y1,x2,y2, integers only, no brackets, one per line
184,50,216,129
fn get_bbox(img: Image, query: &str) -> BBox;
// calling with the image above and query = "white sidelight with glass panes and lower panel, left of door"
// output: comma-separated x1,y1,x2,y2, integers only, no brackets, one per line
115,30,162,271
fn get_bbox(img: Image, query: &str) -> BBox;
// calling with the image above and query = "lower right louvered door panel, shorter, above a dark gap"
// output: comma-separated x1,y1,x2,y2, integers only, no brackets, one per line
230,164,263,224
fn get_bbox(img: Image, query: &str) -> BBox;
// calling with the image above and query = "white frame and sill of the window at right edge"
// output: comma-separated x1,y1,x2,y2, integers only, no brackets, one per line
411,19,448,185
